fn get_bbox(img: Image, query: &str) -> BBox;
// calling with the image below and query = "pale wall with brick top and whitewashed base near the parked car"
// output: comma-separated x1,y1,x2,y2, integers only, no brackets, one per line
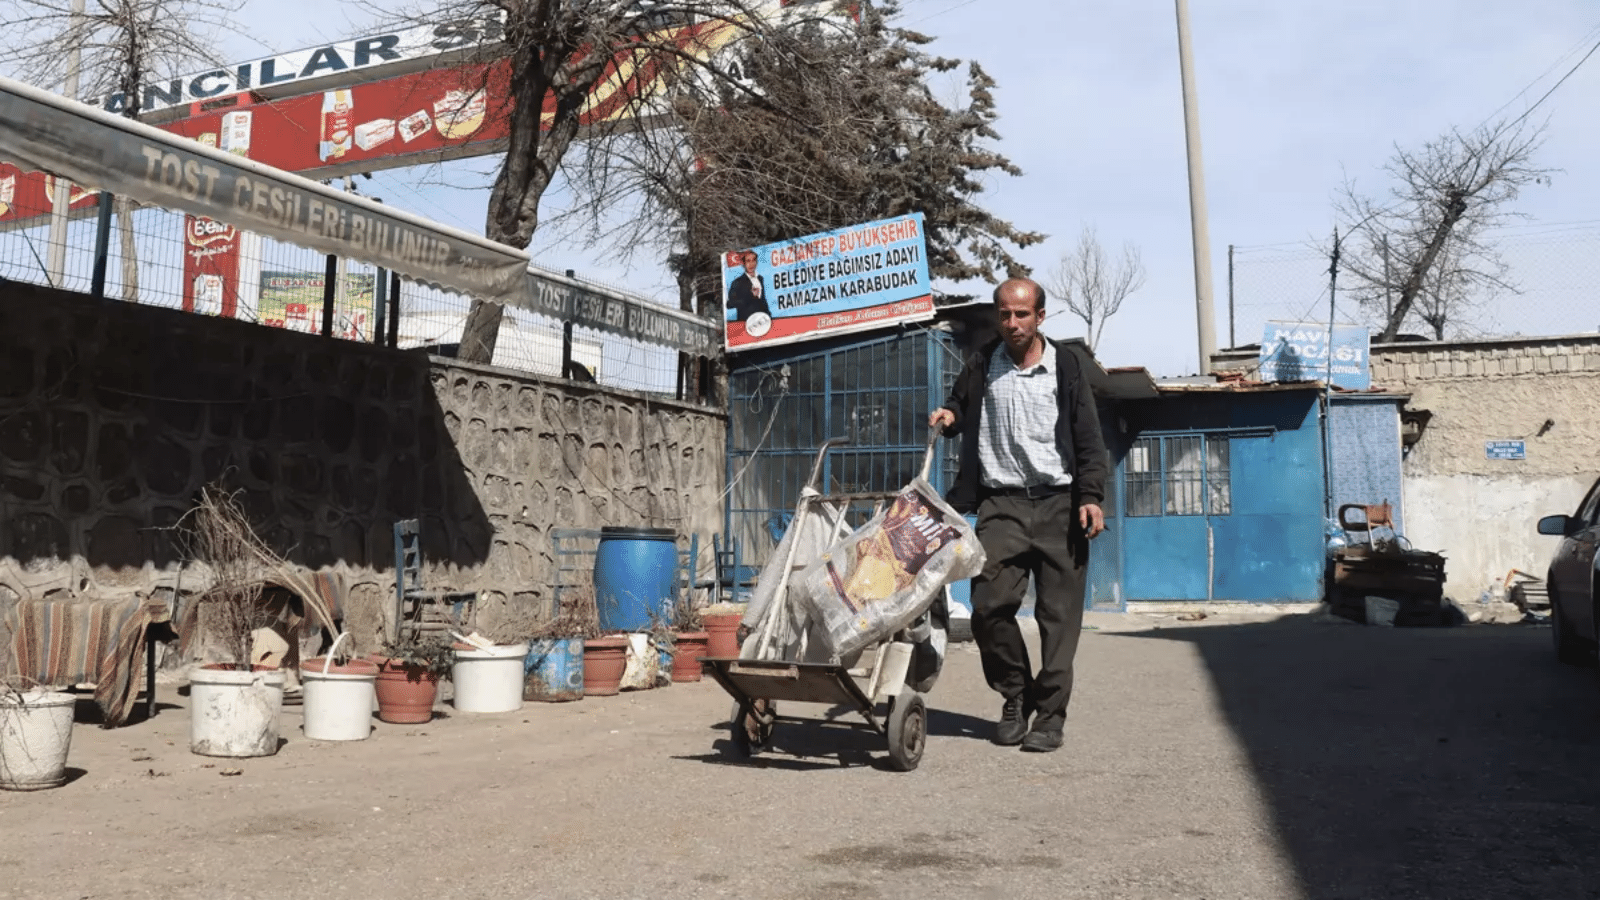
1226,335,1600,602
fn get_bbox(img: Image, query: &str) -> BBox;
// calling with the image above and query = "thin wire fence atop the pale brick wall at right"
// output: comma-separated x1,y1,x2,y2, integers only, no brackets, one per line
1218,223,1600,346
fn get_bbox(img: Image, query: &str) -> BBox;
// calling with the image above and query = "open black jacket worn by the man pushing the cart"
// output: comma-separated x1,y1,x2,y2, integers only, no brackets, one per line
944,338,1109,512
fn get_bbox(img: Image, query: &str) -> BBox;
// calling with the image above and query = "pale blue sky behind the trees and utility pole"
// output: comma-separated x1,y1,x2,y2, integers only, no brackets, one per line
168,0,1600,375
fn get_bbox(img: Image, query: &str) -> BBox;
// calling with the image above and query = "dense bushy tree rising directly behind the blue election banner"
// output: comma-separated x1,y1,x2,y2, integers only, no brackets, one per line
557,3,1043,314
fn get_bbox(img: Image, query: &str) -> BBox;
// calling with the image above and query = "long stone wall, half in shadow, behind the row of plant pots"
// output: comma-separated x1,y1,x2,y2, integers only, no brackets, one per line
0,283,726,636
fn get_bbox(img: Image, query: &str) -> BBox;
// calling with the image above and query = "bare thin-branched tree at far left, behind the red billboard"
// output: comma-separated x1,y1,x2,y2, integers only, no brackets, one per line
0,0,243,301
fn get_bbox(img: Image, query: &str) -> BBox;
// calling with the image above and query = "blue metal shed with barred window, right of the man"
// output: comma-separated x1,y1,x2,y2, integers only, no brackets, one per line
1094,384,1325,602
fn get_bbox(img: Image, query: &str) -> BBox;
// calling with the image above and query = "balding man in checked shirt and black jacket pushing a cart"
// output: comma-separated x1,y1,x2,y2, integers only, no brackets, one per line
928,279,1107,753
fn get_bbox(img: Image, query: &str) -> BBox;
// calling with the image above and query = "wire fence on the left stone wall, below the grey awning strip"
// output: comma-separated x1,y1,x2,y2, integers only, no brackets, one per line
0,165,693,397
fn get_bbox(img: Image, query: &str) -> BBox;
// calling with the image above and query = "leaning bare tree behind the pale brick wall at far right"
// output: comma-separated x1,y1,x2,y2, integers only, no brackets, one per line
1334,120,1552,341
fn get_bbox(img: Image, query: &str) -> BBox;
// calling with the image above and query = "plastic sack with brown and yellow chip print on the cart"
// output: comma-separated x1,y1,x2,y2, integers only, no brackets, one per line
800,477,984,657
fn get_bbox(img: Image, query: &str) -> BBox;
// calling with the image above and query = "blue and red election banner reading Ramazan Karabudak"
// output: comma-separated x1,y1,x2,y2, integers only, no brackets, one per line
722,213,933,352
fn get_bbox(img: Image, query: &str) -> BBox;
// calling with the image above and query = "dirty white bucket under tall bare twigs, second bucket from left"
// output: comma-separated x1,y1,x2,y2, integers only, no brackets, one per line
189,668,285,756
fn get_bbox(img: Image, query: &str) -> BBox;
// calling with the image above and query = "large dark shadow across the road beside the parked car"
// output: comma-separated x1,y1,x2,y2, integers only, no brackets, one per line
1123,617,1600,900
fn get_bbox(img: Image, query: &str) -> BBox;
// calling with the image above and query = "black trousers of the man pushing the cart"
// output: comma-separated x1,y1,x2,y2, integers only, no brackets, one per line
973,490,1090,730
